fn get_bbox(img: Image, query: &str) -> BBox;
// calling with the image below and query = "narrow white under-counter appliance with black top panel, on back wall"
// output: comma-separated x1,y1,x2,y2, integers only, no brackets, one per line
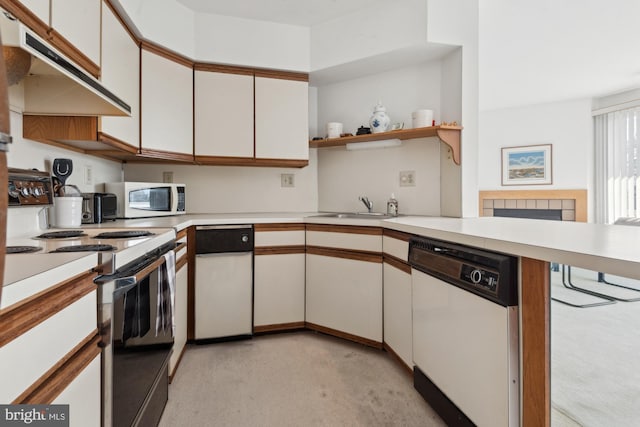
195,225,253,340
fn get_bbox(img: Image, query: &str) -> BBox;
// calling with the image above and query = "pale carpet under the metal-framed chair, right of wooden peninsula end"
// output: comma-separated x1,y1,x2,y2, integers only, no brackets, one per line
551,269,640,427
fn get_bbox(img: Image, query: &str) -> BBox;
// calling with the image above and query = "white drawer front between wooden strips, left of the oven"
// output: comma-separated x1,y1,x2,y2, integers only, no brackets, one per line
0,290,97,402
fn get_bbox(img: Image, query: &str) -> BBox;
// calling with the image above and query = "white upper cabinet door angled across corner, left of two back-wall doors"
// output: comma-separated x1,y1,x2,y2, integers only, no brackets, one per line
140,48,193,156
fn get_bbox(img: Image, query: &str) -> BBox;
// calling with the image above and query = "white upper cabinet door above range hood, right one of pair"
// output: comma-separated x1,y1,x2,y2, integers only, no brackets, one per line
51,0,102,65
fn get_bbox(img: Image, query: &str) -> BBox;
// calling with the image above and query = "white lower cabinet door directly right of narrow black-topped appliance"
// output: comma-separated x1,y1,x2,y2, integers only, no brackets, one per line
253,253,305,330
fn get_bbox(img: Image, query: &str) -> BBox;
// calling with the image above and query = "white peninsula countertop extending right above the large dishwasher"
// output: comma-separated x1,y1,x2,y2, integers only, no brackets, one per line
384,217,640,279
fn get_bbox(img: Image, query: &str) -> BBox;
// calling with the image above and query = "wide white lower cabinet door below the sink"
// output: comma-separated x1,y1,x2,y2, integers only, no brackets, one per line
306,253,382,343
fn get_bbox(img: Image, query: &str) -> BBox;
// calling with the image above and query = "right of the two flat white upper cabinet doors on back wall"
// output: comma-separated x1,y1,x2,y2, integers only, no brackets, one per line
255,76,309,160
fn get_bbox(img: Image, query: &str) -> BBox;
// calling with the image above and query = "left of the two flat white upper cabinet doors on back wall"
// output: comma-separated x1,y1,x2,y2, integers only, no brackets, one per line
194,70,254,158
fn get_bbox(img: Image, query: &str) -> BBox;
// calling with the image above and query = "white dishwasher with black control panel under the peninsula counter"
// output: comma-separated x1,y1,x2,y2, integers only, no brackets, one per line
409,237,520,427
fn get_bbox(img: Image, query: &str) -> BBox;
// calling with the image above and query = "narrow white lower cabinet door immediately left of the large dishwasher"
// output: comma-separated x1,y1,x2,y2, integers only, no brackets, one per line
384,262,413,367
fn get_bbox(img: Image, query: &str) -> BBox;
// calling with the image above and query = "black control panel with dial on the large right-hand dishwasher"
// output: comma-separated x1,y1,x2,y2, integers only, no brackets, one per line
409,237,518,307
